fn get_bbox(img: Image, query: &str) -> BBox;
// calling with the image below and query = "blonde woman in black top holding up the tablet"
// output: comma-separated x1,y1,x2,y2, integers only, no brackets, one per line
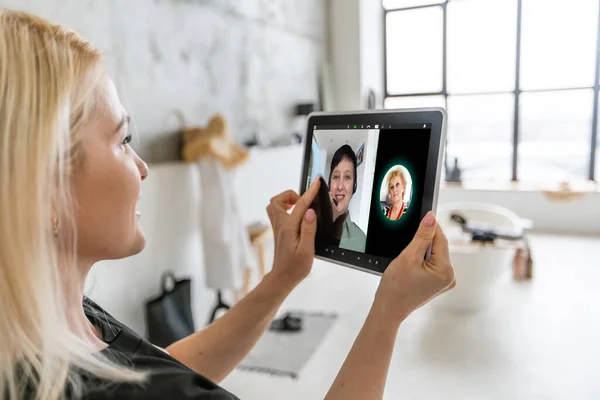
0,10,454,400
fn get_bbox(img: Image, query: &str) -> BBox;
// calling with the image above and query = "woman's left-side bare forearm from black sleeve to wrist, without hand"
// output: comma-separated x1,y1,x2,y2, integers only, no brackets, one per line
166,274,291,383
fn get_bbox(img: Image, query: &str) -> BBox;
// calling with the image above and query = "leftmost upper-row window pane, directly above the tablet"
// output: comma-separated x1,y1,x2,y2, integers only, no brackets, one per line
386,7,442,94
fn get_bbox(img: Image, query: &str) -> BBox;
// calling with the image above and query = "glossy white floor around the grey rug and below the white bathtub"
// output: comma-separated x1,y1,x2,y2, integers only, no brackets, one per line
222,235,600,399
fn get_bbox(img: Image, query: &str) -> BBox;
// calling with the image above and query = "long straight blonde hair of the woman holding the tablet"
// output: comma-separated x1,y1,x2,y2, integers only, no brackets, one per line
0,9,145,399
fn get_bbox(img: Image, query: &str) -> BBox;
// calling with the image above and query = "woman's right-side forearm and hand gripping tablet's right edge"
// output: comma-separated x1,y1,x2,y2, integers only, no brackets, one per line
326,214,455,400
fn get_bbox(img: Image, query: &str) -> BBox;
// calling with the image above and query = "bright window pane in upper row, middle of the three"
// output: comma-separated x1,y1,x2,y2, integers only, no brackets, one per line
448,0,517,93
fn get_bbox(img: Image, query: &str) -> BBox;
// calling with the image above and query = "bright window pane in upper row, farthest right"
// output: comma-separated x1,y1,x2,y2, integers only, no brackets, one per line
521,0,598,90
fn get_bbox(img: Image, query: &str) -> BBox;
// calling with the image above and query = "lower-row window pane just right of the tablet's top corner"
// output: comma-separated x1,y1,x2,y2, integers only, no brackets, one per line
446,94,514,181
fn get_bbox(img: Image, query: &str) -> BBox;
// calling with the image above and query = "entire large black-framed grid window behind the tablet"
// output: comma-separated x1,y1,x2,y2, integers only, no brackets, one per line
383,0,600,184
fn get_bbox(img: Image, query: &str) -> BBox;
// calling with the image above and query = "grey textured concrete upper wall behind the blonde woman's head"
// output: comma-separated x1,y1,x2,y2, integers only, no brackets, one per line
0,0,325,162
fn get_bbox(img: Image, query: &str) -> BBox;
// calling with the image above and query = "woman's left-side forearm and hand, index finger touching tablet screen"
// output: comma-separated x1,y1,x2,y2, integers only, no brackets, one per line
167,181,319,383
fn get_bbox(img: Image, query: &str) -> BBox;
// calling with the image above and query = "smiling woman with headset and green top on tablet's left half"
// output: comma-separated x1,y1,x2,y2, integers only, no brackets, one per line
329,144,367,253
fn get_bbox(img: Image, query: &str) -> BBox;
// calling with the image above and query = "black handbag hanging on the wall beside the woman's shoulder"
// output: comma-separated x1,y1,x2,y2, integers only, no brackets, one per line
146,271,195,348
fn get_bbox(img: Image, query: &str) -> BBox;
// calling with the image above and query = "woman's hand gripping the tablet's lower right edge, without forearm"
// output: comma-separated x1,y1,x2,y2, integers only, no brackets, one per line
375,212,456,323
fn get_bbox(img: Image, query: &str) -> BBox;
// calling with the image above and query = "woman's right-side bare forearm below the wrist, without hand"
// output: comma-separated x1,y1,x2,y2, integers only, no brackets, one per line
325,303,400,400
